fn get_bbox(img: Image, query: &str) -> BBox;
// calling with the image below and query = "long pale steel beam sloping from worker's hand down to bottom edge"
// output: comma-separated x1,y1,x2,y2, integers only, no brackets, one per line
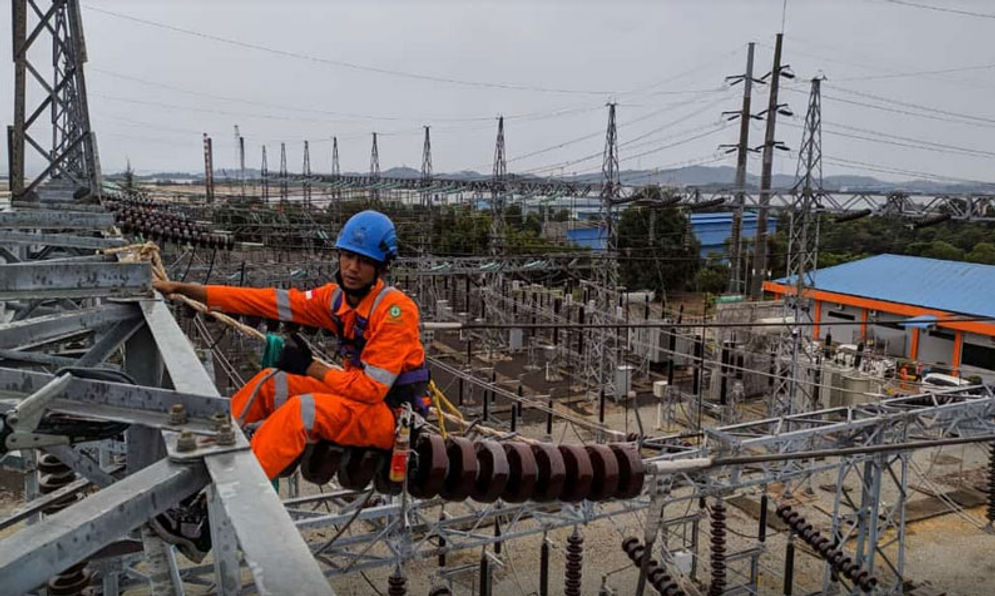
141,300,334,594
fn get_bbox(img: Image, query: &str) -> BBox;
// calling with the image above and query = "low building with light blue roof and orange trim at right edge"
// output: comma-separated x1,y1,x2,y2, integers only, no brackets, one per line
764,254,995,379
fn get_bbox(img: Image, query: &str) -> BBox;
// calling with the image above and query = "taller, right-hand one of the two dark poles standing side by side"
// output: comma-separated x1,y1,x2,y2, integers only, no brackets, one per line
750,33,794,300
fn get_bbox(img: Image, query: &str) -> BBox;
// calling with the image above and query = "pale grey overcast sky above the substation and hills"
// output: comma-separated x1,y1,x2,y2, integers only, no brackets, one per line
0,0,995,181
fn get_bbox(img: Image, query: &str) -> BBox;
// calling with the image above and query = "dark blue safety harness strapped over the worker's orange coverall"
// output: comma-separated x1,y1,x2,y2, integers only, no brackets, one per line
331,285,431,416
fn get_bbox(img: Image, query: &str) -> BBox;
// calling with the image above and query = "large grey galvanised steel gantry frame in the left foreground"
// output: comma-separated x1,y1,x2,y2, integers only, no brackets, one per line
0,186,332,594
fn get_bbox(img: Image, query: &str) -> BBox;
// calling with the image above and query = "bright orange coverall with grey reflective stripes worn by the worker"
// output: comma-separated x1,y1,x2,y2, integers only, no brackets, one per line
207,280,425,479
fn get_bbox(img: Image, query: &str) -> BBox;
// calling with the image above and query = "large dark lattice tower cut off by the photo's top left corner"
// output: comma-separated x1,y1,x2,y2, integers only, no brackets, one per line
7,0,102,199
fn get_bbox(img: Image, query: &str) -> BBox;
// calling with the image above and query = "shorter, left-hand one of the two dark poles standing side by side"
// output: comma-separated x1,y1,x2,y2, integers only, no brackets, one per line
719,42,763,294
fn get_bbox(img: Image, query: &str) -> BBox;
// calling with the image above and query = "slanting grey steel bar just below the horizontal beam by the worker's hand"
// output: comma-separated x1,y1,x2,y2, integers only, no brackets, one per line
0,302,139,348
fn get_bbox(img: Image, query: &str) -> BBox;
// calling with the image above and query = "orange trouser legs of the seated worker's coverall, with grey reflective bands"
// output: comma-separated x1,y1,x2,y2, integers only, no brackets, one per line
231,369,394,478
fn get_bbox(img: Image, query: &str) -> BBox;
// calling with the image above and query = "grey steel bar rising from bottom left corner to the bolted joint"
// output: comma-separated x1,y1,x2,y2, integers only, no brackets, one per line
0,460,208,594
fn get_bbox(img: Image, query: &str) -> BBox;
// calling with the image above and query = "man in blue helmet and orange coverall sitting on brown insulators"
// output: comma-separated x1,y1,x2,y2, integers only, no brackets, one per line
153,211,429,561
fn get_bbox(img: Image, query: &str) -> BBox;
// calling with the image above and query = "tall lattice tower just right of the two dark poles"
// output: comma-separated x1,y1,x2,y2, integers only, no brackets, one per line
771,78,822,416
